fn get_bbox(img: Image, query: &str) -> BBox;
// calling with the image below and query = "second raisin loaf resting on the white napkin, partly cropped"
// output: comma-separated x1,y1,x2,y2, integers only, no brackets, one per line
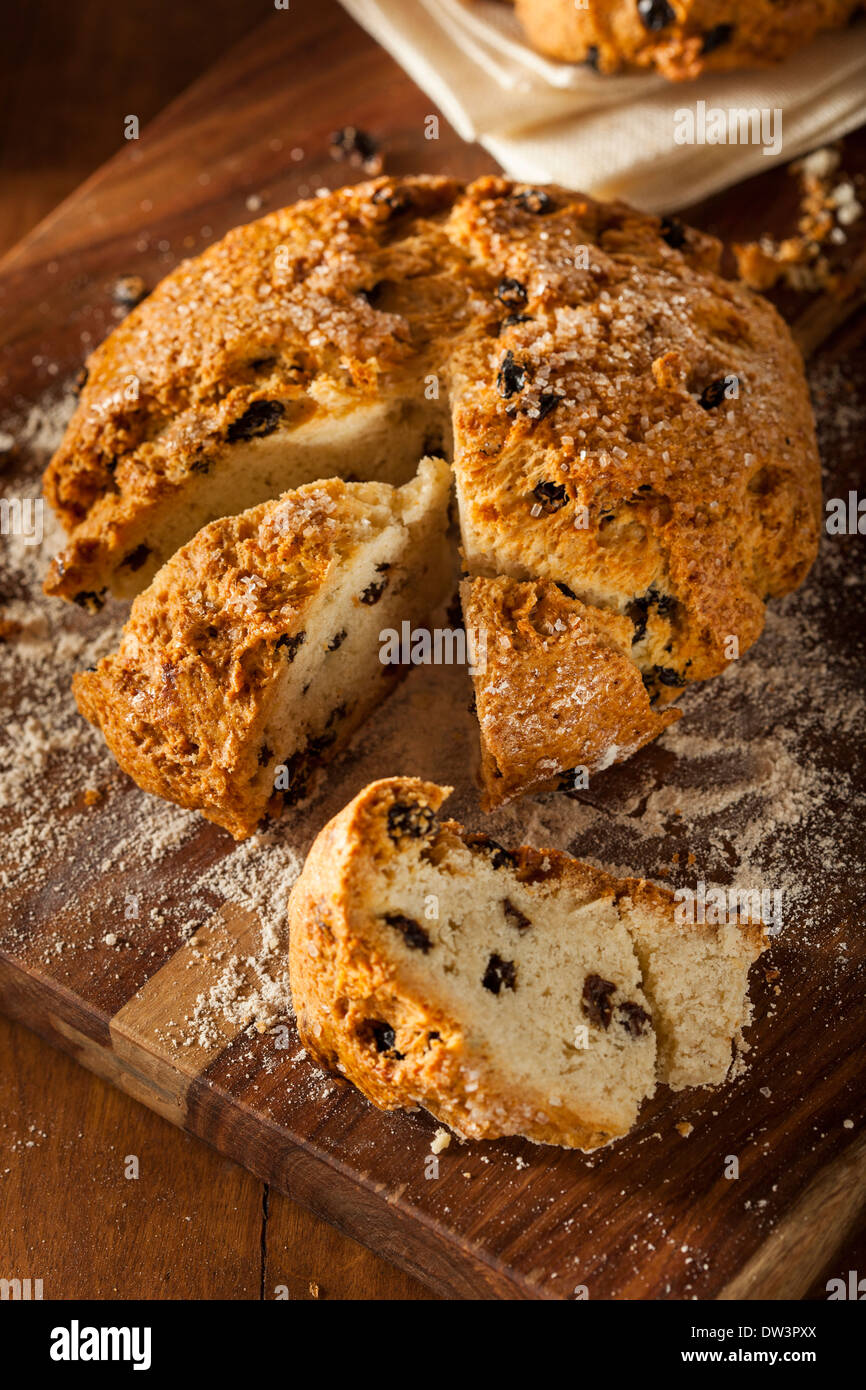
516,0,862,82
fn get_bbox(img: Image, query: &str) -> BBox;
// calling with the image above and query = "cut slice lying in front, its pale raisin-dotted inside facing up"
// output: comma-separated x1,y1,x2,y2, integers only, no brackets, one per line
289,777,763,1150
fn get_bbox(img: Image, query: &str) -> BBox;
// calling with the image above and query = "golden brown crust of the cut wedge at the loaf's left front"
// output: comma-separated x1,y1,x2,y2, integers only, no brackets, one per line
72,480,354,835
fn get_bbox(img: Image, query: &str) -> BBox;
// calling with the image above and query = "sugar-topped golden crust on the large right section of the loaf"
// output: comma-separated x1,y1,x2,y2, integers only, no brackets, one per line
455,179,820,684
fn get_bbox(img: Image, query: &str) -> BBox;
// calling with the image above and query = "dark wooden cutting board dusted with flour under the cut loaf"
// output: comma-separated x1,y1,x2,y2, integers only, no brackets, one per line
0,0,866,1298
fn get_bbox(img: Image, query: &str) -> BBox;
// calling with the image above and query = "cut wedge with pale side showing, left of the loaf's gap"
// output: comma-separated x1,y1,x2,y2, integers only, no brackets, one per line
74,459,450,840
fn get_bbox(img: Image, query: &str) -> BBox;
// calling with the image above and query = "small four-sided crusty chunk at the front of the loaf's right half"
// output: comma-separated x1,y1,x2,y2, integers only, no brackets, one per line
460,577,681,810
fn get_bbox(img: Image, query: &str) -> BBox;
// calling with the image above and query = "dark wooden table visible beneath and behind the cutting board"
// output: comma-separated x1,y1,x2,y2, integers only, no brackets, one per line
0,0,434,1300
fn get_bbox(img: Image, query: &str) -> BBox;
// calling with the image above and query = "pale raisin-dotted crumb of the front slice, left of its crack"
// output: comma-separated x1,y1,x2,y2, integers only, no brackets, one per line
357,833,655,1134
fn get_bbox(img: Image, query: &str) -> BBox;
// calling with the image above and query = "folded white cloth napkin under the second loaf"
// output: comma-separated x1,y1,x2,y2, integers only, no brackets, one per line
342,0,866,213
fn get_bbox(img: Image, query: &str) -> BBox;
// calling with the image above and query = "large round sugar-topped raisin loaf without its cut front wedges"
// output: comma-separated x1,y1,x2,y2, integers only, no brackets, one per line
46,178,820,806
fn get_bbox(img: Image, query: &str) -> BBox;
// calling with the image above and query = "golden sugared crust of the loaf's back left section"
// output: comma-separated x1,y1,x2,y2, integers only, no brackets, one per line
44,177,474,602
